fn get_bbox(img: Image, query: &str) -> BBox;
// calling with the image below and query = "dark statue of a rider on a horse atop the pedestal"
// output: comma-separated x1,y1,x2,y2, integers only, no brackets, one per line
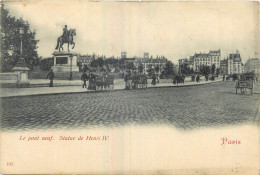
55,25,76,51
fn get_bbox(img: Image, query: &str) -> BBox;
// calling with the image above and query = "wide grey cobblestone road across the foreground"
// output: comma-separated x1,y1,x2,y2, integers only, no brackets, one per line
1,82,259,130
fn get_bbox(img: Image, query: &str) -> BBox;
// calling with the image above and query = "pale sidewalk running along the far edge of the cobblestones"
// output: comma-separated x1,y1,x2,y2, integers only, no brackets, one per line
0,79,220,97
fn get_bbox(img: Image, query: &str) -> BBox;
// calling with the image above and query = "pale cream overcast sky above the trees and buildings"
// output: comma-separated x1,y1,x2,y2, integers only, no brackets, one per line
5,1,259,63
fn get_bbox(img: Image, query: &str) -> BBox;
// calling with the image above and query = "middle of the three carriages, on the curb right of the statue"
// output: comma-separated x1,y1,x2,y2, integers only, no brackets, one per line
125,74,147,89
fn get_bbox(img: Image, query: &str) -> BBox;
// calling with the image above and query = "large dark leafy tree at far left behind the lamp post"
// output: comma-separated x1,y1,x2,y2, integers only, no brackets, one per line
1,4,39,72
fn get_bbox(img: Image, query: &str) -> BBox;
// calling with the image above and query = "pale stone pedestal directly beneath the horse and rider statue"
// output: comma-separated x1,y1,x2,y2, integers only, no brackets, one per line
52,51,79,72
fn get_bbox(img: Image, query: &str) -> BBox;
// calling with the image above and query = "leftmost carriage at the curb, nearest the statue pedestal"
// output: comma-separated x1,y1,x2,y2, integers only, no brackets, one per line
88,74,114,91
